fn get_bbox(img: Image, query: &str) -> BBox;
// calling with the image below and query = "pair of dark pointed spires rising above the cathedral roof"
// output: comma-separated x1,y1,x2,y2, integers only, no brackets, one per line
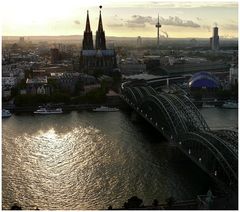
82,10,106,50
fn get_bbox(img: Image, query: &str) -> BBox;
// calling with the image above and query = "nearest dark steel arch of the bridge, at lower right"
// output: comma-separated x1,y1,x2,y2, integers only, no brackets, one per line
178,132,238,186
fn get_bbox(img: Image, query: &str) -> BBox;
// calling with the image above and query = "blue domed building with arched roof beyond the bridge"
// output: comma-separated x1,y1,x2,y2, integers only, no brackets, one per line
188,71,220,89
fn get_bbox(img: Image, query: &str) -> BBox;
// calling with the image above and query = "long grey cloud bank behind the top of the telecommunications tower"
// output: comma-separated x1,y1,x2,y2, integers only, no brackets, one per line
126,15,200,28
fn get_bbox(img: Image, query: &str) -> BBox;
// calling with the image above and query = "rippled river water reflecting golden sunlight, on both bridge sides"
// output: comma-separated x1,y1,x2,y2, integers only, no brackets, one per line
2,108,238,210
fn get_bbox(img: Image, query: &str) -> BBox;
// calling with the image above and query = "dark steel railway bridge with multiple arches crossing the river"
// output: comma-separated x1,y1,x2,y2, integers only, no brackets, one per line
122,82,238,188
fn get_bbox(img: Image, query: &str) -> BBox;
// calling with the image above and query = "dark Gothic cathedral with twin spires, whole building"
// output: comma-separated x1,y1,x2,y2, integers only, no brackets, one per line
80,11,116,74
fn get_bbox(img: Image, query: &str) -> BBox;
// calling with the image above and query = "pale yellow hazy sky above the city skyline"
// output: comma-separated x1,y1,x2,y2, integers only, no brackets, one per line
1,0,238,38
